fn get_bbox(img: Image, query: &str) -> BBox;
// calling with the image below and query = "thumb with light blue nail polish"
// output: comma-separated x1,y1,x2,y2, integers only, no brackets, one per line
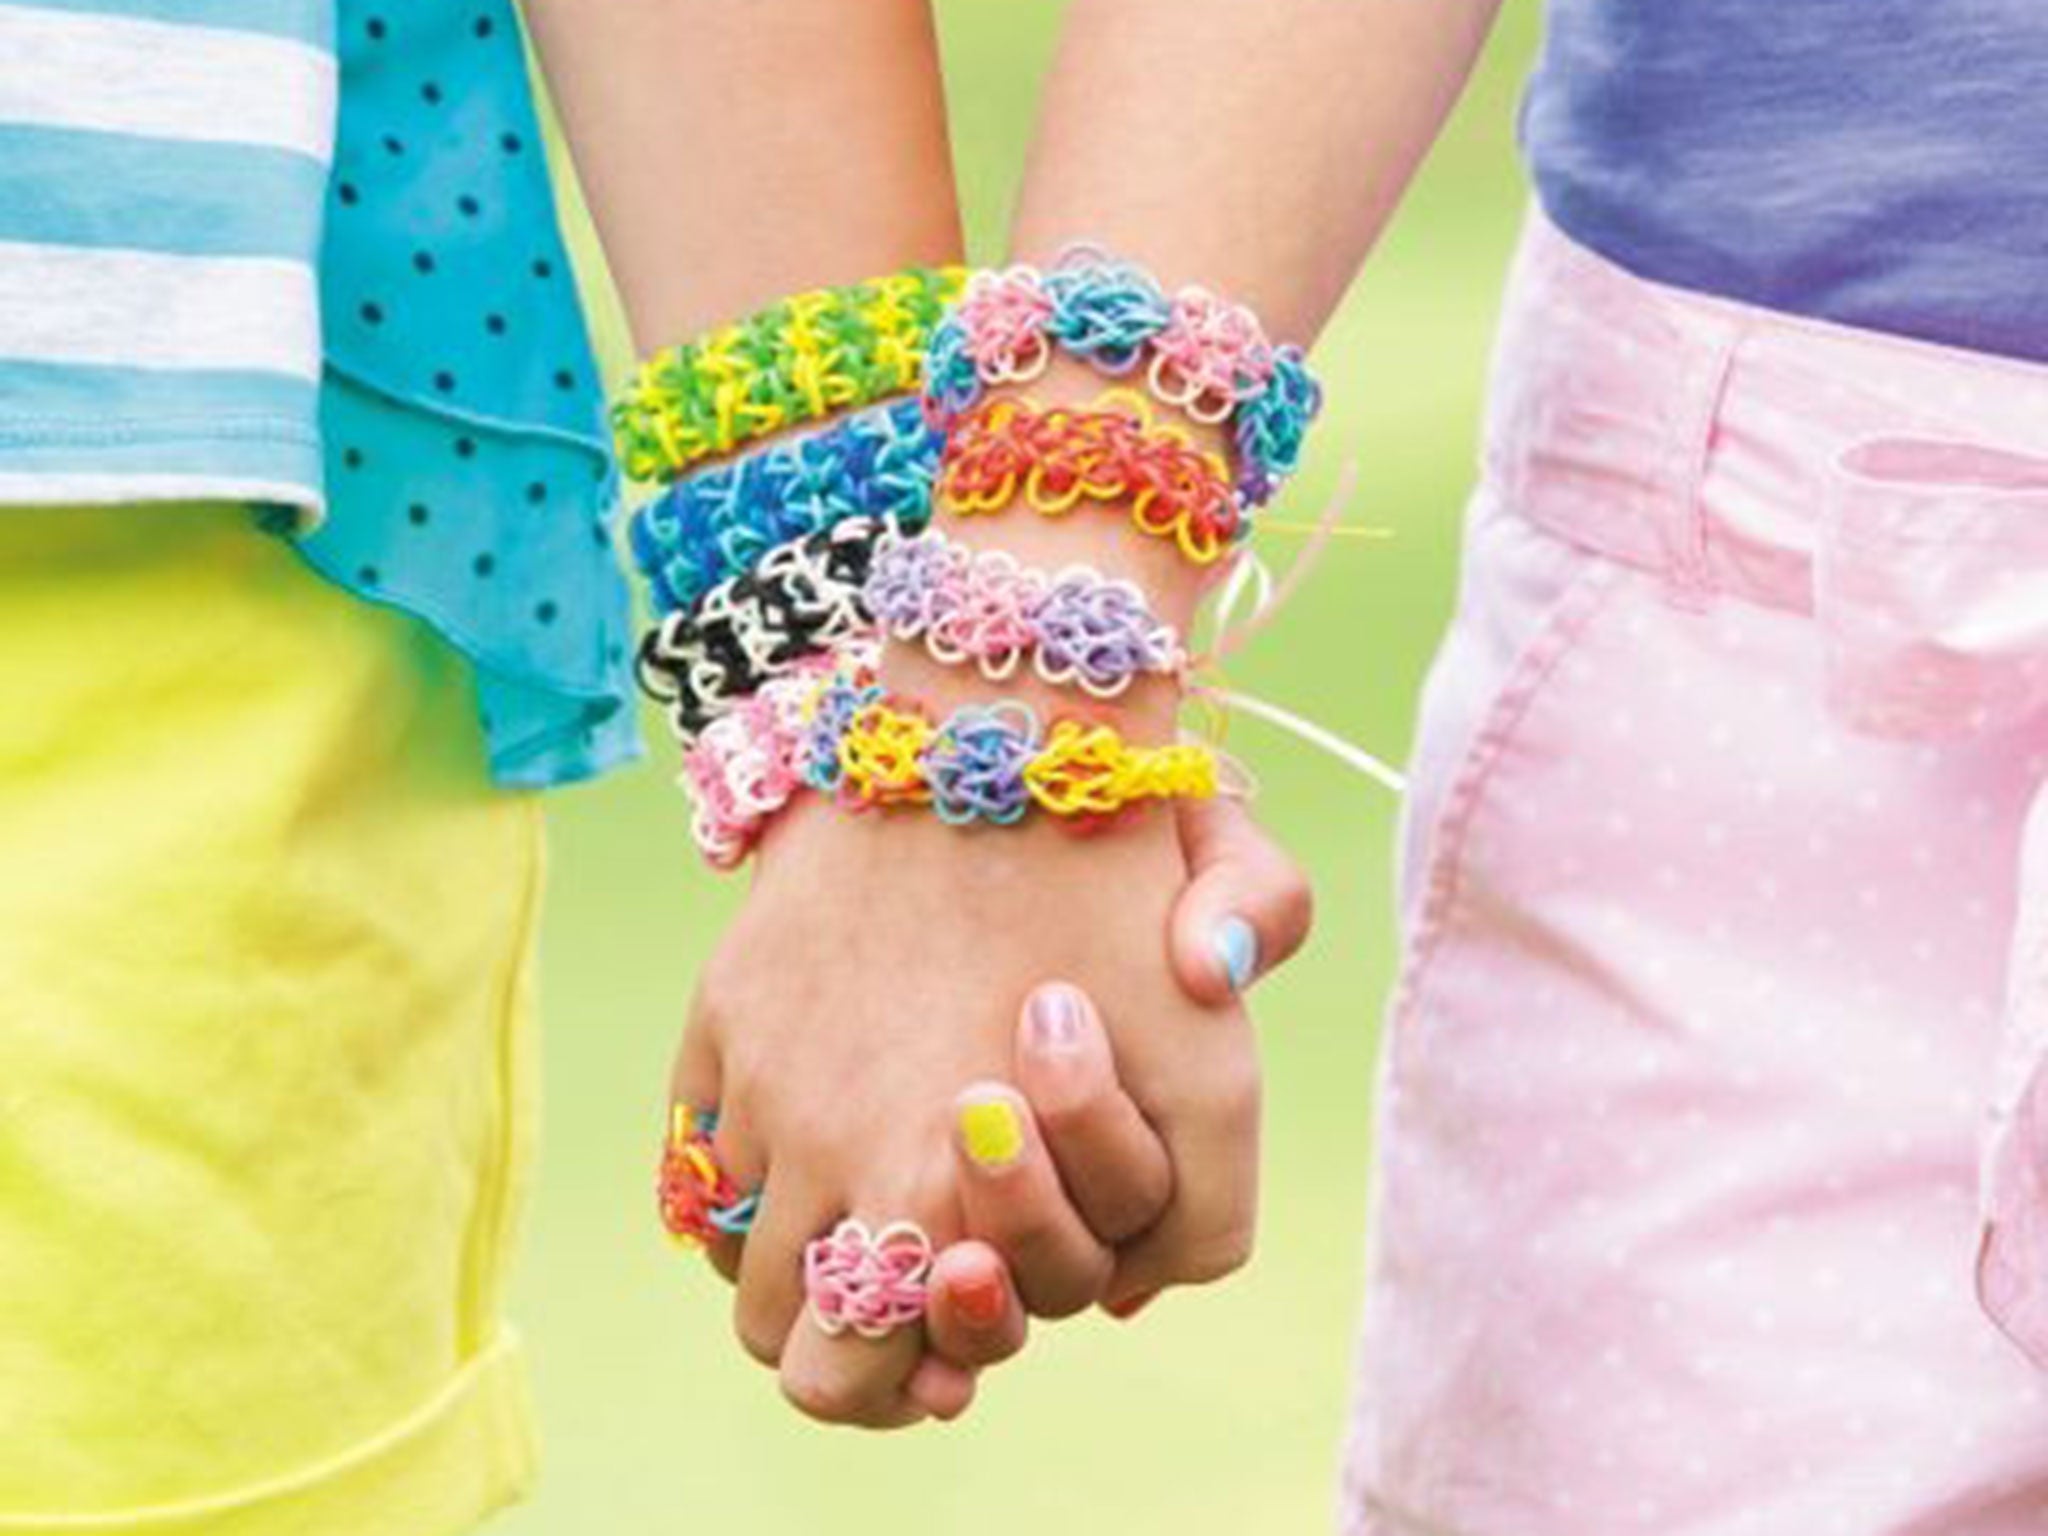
1167,797,1315,1006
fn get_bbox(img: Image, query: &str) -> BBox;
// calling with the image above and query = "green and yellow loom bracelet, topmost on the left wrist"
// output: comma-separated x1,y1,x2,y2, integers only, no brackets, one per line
612,266,967,481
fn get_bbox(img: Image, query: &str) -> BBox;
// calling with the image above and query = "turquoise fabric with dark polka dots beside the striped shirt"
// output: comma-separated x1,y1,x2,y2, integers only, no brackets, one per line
301,0,639,786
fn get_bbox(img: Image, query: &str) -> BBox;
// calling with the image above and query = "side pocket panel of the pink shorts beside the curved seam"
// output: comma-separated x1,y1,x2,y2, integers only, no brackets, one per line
1391,483,1622,1032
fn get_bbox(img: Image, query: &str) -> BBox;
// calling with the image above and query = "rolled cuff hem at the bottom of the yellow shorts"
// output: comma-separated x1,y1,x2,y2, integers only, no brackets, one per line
0,1329,537,1536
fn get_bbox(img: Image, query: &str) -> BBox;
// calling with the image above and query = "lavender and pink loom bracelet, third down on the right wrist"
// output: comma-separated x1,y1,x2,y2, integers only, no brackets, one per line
862,528,1188,698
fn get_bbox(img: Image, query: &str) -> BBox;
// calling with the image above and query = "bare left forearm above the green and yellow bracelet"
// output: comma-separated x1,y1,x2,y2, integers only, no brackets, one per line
526,0,961,350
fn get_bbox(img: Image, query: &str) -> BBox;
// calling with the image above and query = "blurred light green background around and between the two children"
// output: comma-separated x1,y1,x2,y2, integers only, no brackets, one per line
494,0,1536,1536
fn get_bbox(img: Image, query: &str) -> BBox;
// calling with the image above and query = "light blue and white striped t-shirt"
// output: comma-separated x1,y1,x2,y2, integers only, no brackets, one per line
0,0,336,510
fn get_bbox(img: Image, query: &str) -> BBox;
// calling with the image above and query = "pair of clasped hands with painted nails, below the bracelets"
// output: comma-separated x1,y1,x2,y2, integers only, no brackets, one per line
674,753,1311,1427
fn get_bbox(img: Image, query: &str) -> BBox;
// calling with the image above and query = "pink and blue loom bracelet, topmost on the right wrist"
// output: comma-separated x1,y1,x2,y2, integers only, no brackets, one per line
924,246,1323,506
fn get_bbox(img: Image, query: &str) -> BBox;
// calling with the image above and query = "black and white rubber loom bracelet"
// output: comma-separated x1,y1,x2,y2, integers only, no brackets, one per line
637,516,895,745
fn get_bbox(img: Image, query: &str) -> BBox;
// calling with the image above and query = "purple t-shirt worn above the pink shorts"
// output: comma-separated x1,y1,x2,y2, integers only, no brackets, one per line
1522,0,2048,360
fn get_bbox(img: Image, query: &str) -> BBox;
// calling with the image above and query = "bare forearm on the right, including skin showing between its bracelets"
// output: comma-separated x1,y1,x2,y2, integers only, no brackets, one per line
917,0,1499,708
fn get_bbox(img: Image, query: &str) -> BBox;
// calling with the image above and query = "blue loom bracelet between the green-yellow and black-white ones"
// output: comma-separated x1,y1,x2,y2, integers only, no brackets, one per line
631,399,942,614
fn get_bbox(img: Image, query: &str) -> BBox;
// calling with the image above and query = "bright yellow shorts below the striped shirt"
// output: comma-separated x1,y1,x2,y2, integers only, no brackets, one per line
0,506,541,1536
